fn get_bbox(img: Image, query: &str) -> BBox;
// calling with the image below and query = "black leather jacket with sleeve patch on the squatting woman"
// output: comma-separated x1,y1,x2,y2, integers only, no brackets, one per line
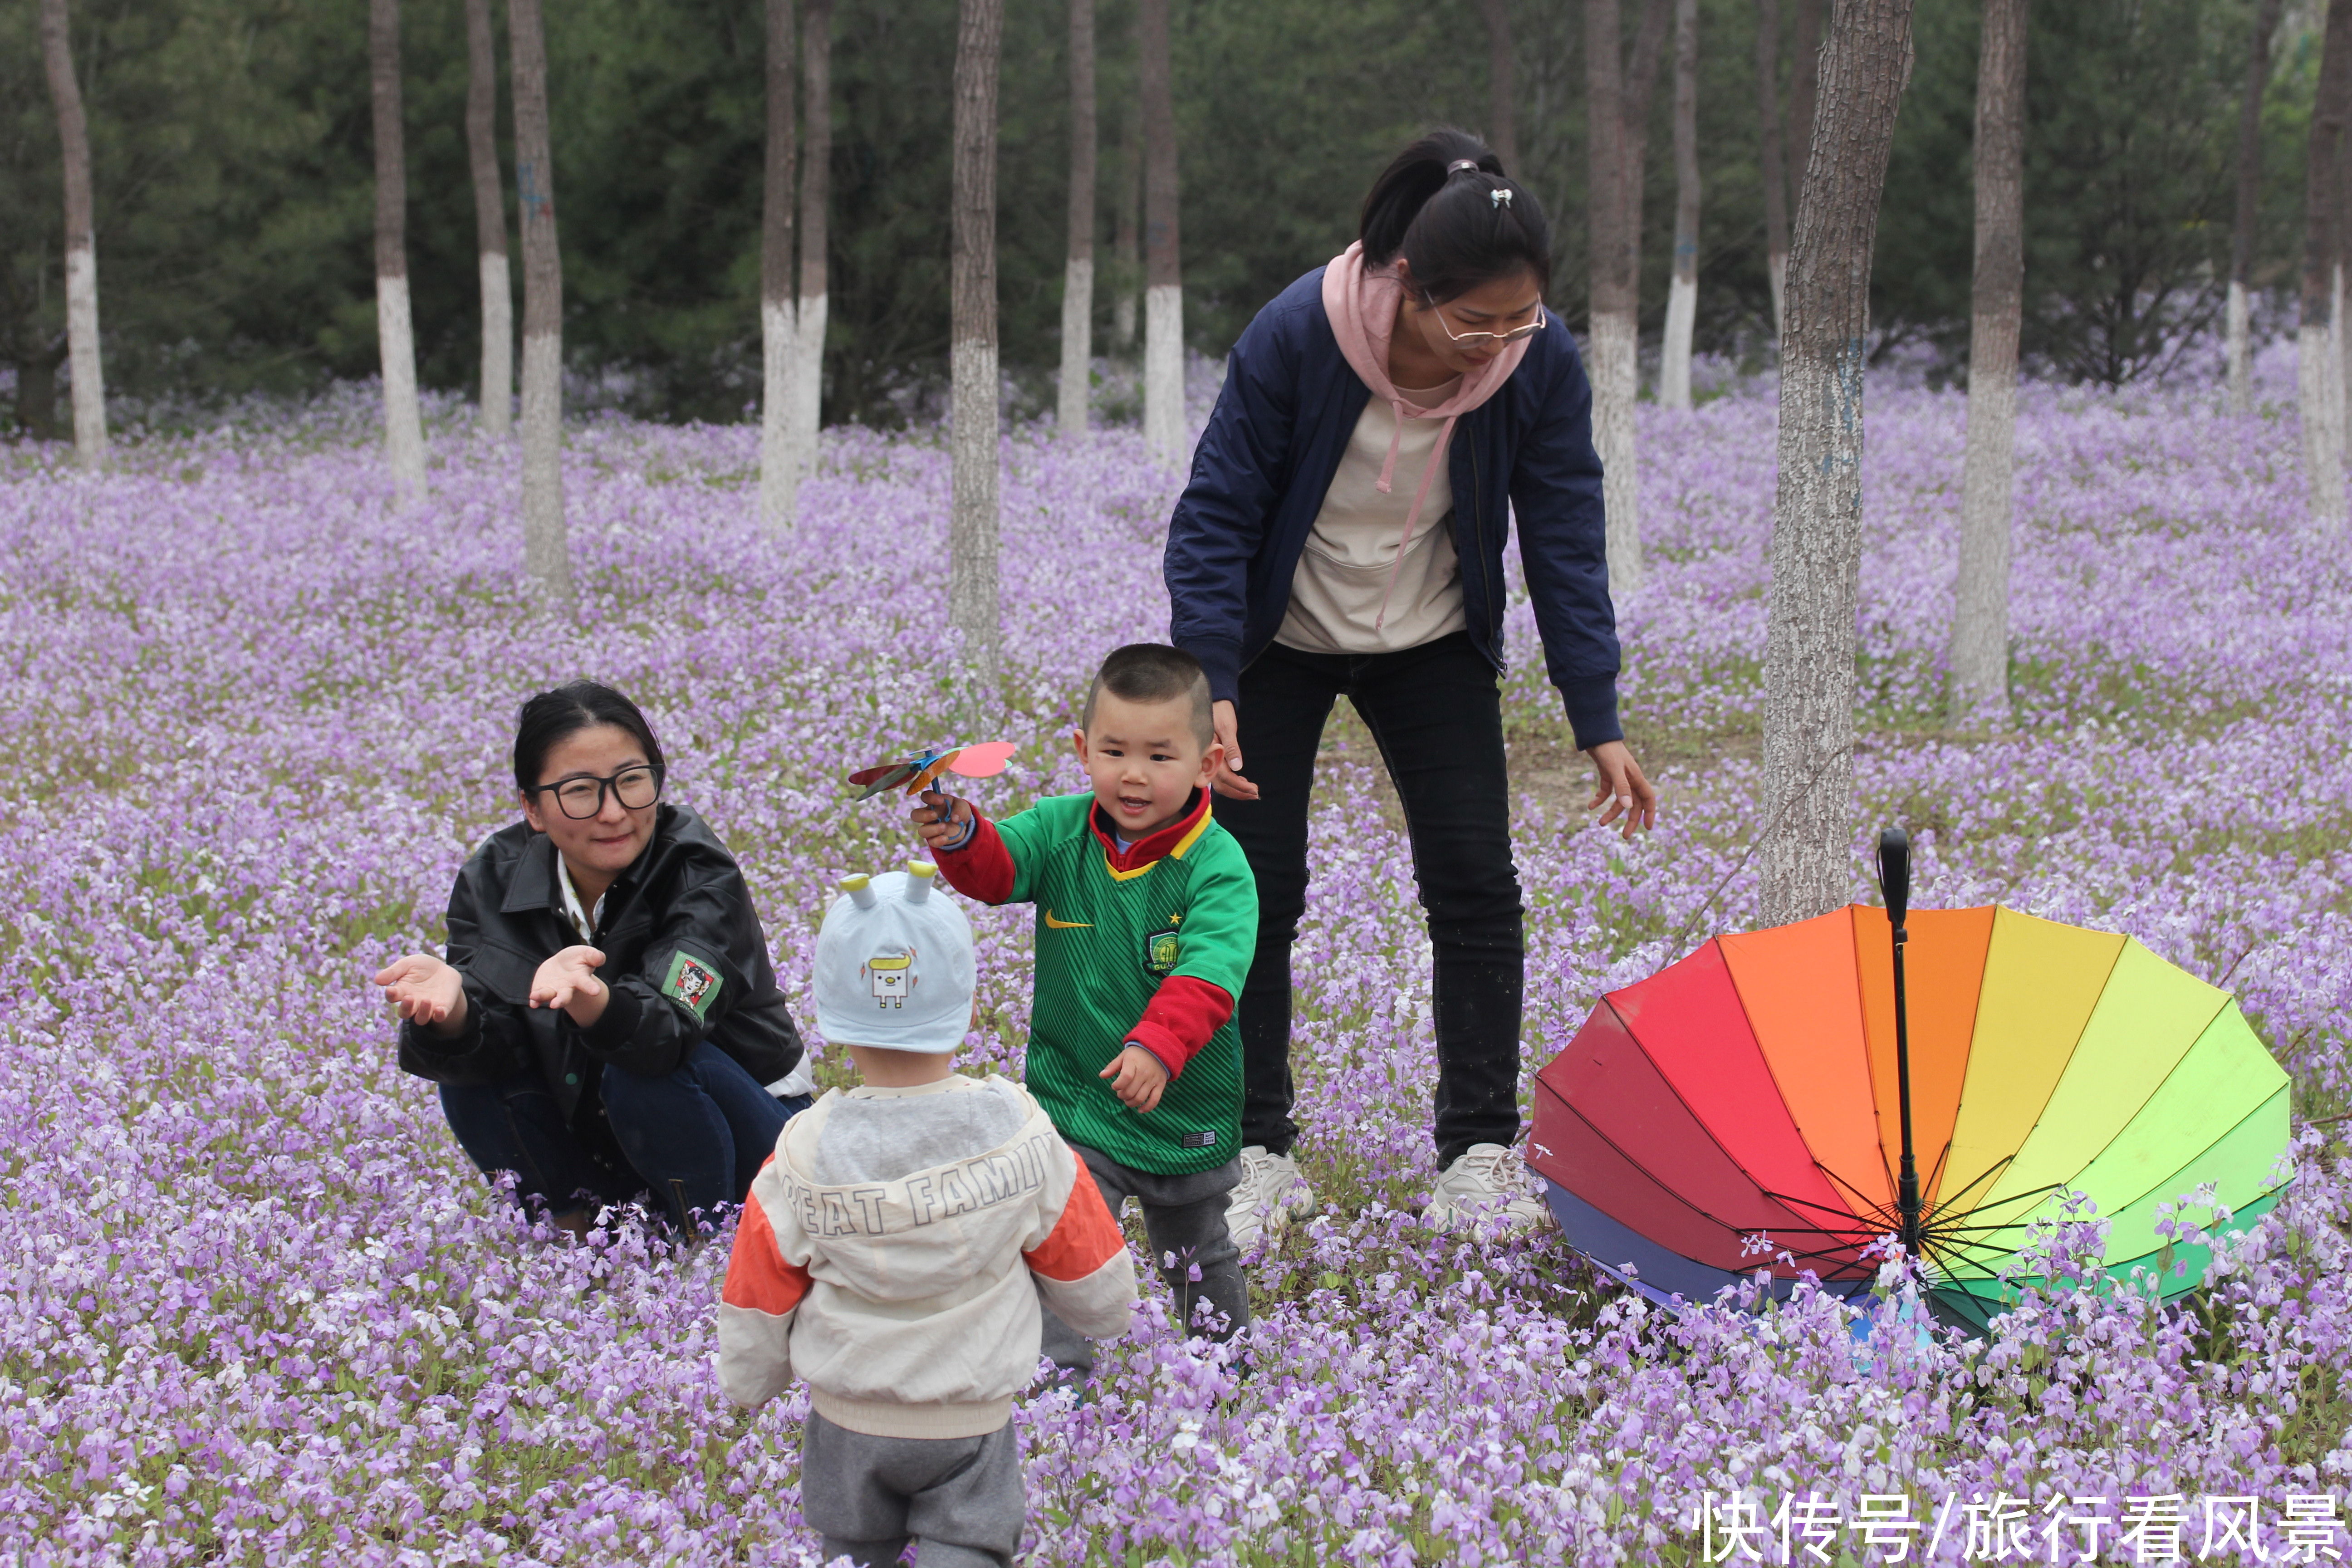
400,804,802,1142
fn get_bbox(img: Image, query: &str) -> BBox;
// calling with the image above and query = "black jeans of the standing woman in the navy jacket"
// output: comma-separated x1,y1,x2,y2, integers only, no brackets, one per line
1216,632,1526,1166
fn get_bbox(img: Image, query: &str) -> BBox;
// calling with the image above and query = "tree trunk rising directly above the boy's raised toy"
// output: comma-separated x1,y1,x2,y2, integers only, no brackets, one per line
948,0,1004,691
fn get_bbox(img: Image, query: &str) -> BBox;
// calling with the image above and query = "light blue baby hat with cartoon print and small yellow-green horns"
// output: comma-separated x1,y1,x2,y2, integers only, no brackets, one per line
811,860,974,1053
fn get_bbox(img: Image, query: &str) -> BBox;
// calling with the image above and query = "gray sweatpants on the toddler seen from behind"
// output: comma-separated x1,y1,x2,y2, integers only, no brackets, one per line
800,1411,1028,1568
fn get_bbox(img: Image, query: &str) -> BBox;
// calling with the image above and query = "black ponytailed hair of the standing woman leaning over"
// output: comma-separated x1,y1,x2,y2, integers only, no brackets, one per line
1357,129,1552,303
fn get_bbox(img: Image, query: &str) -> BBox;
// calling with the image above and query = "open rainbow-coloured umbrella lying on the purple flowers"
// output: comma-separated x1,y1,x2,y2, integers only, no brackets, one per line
1529,841,2286,1326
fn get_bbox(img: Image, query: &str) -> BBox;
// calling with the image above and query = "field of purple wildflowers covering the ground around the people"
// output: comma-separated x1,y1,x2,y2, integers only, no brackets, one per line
0,358,2352,1566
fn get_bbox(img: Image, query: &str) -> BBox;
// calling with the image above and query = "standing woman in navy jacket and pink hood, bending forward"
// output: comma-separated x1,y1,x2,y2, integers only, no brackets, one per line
1166,129,1658,1248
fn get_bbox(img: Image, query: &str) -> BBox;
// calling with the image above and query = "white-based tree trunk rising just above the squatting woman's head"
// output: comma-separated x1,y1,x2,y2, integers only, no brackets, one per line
506,0,574,604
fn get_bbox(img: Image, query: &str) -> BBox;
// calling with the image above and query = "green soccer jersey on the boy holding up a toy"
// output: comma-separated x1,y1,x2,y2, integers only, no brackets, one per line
997,792,1258,1176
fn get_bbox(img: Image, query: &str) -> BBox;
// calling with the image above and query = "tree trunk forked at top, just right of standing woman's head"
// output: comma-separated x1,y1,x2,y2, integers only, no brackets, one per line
1585,0,1672,593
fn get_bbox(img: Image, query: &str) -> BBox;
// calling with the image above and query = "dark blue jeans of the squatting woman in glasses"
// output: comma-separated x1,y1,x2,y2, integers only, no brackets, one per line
442,1041,809,1230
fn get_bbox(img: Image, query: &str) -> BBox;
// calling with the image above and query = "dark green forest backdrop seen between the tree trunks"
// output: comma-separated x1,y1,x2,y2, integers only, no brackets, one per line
0,0,2319,435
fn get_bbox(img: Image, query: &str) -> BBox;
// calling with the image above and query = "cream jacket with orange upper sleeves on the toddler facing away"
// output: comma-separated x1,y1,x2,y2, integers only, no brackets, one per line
720,1079,1136,1436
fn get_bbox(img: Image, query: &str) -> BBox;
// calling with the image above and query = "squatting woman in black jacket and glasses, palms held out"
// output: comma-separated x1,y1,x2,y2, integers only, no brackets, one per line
376,682,811,1234
